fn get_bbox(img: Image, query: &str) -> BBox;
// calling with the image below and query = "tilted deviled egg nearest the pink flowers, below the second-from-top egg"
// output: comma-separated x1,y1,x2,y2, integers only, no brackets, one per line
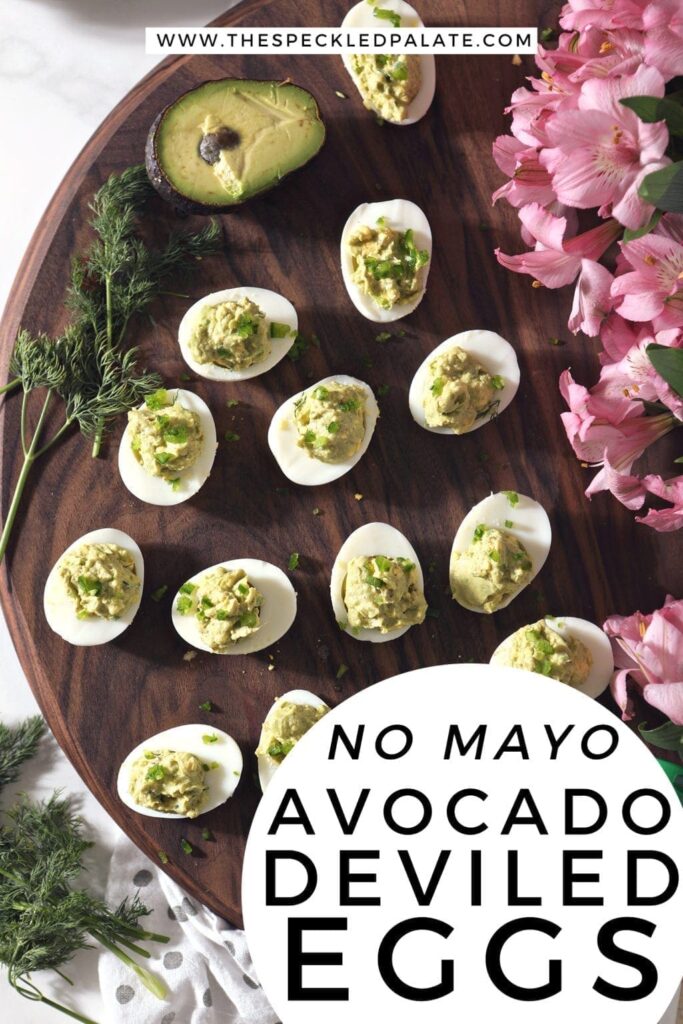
408,331,519,434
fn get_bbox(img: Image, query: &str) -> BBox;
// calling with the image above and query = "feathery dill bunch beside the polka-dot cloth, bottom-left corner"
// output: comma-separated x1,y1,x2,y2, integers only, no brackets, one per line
0,794,168,1024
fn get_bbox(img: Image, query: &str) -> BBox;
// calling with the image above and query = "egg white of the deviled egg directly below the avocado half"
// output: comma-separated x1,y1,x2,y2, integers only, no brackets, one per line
178,287,299,381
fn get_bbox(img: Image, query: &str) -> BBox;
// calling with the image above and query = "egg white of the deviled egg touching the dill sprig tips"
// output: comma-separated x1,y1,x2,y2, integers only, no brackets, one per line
119,388,216,505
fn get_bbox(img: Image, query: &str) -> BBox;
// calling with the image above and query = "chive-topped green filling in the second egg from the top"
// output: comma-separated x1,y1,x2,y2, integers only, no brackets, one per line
348,228,429,309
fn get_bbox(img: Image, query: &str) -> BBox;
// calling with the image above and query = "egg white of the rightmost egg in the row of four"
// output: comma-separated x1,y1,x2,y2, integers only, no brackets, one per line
451,490,552,614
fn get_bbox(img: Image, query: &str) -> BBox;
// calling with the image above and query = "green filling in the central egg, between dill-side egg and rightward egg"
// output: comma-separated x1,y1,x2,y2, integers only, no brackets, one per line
294,381,366,462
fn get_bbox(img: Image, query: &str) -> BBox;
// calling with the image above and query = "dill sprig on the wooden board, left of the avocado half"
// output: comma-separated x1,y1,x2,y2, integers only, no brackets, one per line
0,166,220,561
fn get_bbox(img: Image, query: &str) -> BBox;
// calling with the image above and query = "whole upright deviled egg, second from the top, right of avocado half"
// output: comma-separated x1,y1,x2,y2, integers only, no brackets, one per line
341,199,432,323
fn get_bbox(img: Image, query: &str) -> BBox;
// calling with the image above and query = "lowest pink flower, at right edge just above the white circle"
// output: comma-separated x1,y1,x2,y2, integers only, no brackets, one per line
602,596,683,725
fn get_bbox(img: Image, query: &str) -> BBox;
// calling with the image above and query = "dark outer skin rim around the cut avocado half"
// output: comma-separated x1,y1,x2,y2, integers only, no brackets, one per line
144,78,327,215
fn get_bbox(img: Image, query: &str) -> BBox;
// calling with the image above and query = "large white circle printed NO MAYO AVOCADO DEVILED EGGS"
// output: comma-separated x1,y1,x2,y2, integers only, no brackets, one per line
243,665,683,1024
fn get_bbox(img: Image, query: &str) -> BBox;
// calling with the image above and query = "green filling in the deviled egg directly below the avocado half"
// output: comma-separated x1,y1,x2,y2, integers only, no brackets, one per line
187,298,270,370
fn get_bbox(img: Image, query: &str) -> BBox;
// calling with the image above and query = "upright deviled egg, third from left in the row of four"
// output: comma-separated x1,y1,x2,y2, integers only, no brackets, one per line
330,522,427,643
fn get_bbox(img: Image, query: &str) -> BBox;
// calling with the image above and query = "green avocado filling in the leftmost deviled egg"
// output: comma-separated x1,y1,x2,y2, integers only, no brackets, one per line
58,544,140,618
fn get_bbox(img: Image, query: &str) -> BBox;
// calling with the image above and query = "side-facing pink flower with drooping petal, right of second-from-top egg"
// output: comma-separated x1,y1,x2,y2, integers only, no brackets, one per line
496,203,621,336
